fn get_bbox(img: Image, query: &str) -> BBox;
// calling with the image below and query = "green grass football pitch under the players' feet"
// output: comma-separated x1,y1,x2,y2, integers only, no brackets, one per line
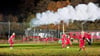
0,43,100,56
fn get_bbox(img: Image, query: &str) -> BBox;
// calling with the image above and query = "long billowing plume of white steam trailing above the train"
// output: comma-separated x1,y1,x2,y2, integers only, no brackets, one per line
30,2,100,26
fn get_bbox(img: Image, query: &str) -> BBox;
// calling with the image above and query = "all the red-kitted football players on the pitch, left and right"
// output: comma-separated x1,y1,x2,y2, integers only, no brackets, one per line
8,31,91,51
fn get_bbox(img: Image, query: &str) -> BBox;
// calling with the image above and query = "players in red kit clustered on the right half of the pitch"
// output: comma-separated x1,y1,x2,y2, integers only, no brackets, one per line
61,31,91,51
